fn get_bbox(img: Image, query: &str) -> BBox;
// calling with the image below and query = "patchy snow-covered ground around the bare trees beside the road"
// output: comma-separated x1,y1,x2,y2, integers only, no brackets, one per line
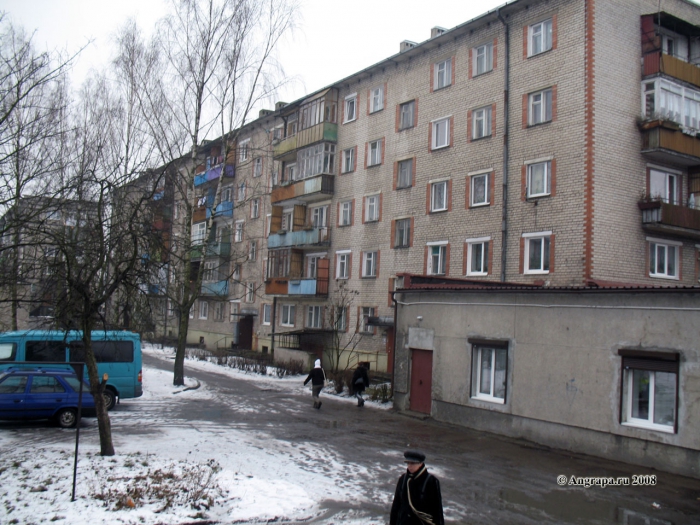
0,345,392,525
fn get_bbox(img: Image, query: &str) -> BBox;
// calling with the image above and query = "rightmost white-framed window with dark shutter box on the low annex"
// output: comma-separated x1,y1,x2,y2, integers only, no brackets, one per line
618,349,678,432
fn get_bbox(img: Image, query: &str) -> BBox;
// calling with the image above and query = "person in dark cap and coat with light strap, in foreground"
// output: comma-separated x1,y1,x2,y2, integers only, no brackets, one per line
389,450,445,525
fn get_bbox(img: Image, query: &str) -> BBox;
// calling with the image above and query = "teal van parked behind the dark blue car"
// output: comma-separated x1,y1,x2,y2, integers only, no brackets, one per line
0,330,143,410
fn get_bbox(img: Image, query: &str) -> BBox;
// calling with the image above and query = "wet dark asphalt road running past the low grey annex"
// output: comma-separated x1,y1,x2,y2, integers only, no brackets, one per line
0,355,700,525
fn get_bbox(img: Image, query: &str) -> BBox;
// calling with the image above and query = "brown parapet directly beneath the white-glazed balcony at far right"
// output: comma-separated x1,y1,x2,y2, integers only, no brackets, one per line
639,120,700,166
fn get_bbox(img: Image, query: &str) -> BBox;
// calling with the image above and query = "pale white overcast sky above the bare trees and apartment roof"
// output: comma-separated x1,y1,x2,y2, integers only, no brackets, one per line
0,0,506,106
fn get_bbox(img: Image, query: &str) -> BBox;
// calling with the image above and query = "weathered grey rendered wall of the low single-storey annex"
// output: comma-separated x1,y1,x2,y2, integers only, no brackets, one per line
394,290,700,477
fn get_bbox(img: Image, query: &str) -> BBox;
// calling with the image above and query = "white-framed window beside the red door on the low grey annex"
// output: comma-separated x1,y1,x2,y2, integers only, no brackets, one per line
472,344,508,403
